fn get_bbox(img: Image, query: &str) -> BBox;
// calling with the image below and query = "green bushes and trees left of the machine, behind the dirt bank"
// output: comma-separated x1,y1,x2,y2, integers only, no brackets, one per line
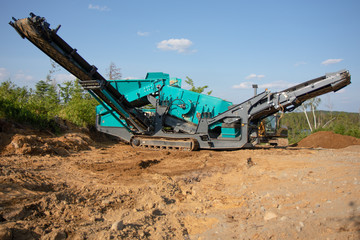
0,61,121,132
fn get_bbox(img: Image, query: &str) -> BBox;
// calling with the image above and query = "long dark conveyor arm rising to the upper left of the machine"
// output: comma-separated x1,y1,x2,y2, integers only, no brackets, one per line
9,13,147,132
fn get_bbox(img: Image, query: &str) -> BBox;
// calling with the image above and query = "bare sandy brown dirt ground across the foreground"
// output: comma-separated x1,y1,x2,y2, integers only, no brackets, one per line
0,122,360,240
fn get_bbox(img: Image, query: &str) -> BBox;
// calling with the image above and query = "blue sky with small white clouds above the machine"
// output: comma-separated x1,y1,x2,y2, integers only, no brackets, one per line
0,0,360,112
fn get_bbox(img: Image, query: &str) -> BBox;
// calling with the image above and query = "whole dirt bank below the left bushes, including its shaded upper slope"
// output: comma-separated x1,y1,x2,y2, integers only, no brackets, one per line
0,118,118,156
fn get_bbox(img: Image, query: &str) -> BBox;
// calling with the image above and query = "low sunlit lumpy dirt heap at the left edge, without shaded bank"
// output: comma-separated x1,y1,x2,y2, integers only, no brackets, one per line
1,133,94,156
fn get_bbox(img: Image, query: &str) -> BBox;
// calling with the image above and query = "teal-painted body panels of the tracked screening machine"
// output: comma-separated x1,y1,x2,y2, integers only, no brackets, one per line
93,72,233,133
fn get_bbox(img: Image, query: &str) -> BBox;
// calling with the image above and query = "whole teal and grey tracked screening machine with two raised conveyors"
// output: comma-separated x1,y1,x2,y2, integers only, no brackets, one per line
10,13,350,150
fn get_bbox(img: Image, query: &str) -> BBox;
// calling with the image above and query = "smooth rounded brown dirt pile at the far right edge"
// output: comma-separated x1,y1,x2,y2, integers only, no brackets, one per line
297,131,360,149
